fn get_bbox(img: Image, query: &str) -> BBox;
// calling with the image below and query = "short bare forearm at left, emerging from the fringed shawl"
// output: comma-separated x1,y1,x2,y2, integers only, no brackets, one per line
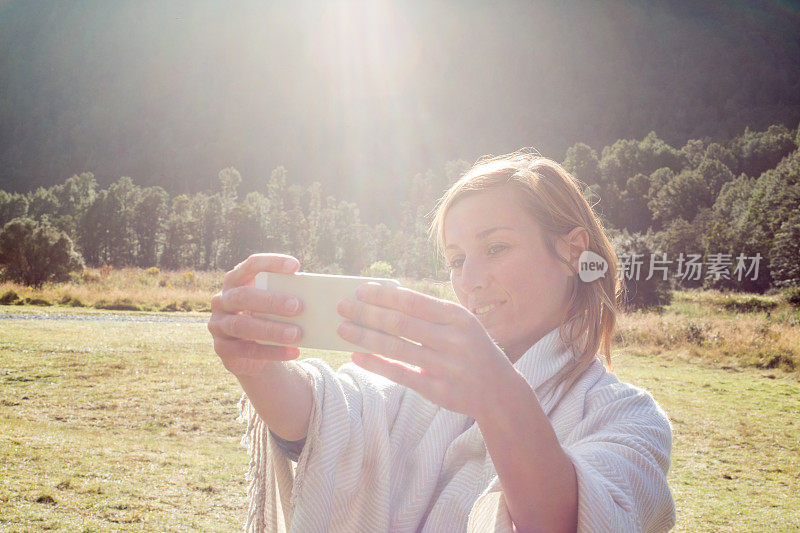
237,361,314,440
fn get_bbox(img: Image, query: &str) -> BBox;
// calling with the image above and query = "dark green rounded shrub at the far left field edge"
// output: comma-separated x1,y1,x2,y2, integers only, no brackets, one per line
0,218,83,287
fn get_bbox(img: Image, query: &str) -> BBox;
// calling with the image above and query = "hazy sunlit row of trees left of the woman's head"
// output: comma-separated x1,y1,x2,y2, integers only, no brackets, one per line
0,167,450,278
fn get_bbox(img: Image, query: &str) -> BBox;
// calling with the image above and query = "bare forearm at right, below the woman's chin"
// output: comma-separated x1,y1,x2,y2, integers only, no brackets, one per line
477,374,578,532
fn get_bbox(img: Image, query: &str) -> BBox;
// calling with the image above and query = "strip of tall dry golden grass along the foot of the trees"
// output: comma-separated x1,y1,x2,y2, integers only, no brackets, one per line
0,267,800,379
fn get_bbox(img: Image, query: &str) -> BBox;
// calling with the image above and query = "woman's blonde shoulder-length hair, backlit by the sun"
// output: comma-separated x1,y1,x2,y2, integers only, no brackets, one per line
430,150,620,381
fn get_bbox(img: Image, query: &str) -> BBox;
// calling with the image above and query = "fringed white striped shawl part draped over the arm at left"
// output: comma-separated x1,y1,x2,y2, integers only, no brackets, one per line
242,359,404,532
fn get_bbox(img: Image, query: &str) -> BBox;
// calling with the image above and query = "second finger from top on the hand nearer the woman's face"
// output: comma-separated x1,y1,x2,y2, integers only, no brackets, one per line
337,298,448,350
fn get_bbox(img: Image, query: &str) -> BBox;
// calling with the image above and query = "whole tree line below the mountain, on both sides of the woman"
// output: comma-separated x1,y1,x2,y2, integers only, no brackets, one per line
0,125,800,298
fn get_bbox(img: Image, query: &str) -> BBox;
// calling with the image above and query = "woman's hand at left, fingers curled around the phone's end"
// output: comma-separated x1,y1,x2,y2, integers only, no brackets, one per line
208,254,303,377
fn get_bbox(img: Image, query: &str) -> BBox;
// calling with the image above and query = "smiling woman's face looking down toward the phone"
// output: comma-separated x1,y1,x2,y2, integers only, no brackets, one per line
444,186,571,362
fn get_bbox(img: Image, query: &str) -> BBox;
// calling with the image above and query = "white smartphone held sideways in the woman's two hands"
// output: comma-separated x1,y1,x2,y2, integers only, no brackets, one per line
255,272,400,352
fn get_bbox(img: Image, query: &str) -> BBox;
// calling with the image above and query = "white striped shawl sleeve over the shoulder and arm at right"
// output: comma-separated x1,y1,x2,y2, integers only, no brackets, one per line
563,378,675,532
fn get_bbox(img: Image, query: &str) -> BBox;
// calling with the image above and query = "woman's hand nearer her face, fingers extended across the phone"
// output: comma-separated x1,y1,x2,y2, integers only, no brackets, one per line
338,283,521,420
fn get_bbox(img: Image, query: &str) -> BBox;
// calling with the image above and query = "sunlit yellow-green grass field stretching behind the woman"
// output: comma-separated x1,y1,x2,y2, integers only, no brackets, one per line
0,293,800,531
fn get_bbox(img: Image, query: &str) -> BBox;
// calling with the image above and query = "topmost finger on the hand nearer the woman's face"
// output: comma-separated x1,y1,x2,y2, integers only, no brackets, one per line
356,283,462,324
